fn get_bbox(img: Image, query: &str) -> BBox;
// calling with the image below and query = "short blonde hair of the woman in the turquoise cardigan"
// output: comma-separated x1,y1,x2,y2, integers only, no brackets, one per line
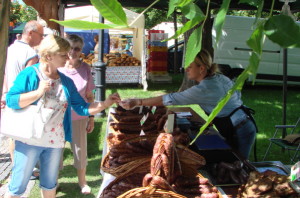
38,34,71,62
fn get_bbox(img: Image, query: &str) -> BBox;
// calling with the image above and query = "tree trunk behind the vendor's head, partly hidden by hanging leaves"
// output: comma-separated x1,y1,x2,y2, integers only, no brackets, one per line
178,11,214,92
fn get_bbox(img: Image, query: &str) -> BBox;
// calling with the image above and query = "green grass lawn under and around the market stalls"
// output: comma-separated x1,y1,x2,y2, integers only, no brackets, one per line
30,74,300,198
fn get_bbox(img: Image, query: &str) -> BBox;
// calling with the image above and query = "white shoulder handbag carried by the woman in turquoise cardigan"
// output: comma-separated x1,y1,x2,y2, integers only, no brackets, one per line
0,67,55,141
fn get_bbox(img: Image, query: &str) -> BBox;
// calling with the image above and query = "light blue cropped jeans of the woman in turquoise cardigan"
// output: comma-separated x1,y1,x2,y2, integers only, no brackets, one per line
8,141,63,196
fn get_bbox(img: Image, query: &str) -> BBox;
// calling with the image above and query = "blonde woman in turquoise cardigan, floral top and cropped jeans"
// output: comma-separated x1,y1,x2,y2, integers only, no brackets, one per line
6,35,120,198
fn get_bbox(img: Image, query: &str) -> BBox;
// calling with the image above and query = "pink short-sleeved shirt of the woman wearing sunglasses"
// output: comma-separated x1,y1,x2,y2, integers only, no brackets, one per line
59,62,95,120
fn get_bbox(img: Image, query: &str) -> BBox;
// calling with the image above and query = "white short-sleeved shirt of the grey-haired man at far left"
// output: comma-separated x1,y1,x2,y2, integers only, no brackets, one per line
5,40,38,89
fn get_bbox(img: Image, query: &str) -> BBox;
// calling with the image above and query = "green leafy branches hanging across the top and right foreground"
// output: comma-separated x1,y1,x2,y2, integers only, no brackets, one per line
53,0,300,144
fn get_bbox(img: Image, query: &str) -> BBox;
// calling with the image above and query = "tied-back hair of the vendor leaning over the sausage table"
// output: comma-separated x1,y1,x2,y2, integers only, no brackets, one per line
194,49,218,76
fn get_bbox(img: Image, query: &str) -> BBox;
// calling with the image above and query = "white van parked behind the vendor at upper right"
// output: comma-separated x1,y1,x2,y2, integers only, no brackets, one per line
213,16,300,84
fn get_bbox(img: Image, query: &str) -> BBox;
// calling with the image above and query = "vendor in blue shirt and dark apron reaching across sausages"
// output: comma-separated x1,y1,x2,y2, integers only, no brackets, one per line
120,50,256,159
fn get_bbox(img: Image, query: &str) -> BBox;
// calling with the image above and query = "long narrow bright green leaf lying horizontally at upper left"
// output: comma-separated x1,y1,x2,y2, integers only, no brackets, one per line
50,19,128,30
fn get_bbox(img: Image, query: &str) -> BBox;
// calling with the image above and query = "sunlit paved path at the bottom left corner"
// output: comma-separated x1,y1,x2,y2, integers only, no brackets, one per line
0,136,35,198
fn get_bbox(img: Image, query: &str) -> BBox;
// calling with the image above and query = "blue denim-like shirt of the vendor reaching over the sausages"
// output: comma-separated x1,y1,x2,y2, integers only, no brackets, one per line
163,74,246,123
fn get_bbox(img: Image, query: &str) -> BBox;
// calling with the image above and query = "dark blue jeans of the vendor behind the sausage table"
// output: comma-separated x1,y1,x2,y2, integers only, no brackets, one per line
236,119,256,159
